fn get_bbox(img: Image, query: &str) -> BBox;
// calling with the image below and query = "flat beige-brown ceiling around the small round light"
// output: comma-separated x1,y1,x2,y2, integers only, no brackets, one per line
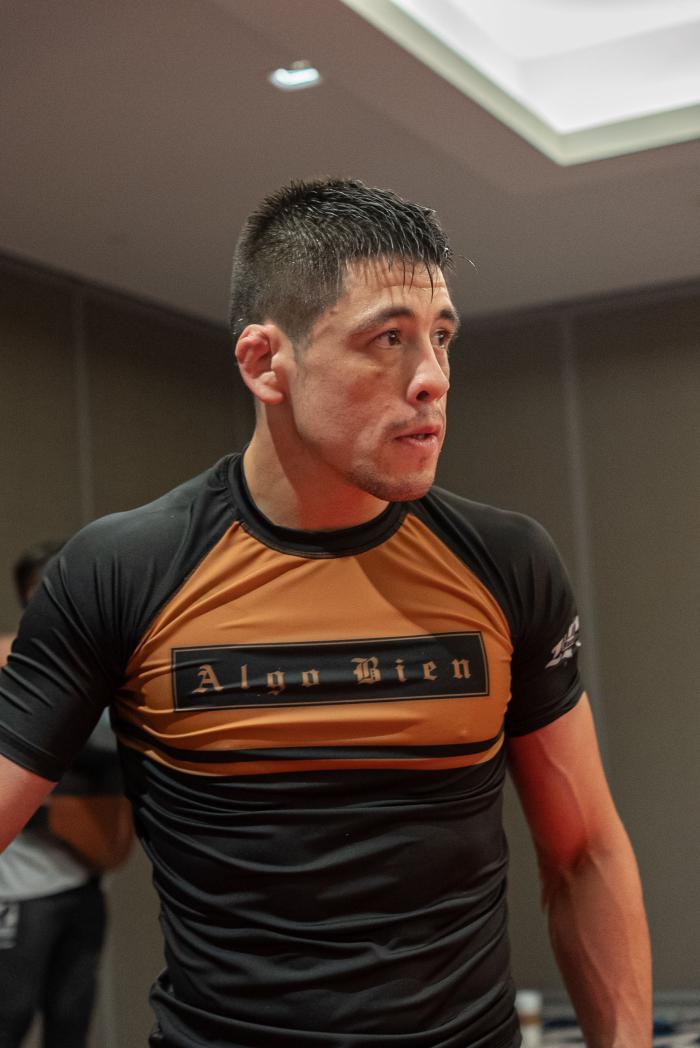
0,0,700,323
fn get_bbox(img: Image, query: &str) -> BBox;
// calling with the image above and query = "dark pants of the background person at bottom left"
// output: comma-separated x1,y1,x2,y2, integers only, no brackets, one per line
0,880,106,1048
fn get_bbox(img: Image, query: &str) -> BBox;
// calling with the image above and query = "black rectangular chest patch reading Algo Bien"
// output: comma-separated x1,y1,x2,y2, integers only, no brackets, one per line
172,631,488,709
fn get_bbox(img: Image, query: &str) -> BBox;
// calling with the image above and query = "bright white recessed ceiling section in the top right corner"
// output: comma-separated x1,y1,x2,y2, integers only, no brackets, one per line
352,0,700,165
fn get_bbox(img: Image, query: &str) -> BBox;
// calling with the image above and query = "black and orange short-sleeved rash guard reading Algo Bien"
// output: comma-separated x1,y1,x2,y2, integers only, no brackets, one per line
0,456,582,1048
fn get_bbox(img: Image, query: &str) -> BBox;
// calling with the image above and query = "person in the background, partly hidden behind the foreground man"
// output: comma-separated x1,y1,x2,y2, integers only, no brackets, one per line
0,541,132,1048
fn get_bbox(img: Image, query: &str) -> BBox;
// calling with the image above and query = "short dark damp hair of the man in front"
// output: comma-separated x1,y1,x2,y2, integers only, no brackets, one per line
229,178,452,343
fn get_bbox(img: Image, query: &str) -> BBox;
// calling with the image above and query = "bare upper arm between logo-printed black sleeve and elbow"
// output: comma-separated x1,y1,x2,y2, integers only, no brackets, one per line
508,695,621,870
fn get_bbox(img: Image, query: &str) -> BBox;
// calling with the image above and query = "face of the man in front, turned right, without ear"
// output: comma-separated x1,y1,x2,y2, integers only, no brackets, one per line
280,260,458,501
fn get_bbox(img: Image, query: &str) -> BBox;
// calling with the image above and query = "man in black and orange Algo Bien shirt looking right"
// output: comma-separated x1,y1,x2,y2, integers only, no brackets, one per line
0,180,651,1048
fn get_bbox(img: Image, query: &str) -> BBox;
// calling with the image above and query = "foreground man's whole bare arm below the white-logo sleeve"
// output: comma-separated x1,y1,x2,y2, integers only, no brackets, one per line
508,695,652,1048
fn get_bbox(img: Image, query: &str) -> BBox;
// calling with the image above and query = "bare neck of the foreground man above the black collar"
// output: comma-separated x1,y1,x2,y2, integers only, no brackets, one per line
243,427,388,531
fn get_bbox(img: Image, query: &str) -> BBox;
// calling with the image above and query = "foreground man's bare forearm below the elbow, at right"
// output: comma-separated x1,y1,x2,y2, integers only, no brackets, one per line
543,825,652,1048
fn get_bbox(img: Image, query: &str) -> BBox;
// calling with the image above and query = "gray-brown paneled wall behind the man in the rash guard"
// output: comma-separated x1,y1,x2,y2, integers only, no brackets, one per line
0,253,700,1048
